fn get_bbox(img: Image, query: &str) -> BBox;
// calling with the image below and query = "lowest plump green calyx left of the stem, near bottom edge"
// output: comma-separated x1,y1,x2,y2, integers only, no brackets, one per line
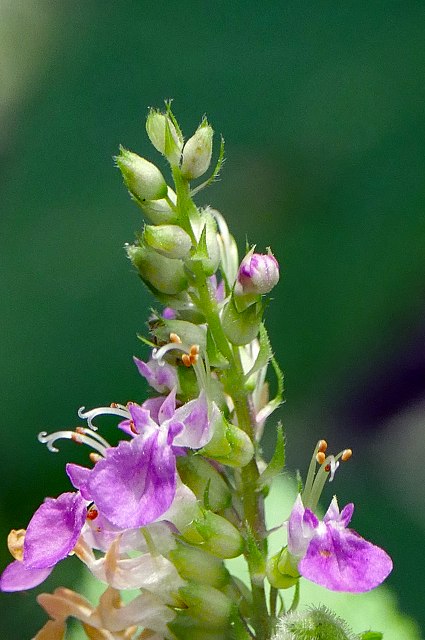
179,583,233,629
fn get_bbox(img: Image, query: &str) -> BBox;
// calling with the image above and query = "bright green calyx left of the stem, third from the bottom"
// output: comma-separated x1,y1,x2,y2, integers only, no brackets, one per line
182,511,244,560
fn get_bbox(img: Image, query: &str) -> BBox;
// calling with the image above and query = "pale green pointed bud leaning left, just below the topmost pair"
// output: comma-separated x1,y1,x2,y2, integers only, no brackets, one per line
115,147,167,200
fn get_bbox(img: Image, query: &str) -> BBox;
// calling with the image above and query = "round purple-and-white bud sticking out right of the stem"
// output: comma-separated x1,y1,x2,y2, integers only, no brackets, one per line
234,249,279,296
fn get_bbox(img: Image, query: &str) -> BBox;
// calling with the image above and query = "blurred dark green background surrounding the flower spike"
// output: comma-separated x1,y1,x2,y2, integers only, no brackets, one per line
0,0,425,640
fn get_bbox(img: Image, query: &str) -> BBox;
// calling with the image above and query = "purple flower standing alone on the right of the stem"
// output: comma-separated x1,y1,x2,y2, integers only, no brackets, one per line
288,495,393,593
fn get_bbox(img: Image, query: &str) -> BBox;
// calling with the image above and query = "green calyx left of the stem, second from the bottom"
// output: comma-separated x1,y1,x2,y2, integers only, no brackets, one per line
169,541,229,589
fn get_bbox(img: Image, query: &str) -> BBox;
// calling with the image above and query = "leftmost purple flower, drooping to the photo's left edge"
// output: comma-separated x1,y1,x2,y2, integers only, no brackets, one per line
0,493,87,591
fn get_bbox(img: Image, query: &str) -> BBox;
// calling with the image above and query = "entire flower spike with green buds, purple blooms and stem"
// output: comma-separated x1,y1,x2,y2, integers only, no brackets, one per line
0,104,392,640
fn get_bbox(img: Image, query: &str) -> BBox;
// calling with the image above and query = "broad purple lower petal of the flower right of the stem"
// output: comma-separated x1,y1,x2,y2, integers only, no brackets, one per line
298,524,393,593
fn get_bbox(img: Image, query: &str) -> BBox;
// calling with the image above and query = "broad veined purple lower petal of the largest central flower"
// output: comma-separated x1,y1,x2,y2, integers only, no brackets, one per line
89,428,176,529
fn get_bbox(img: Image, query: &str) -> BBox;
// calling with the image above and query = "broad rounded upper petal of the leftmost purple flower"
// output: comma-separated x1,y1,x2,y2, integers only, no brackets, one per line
24,493,86,569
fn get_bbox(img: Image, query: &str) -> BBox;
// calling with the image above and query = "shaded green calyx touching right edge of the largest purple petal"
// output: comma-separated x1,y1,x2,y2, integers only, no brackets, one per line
177,455,232,511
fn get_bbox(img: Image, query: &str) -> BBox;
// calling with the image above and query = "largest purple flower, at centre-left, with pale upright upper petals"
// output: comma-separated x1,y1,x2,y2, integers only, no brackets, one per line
67,389,211,529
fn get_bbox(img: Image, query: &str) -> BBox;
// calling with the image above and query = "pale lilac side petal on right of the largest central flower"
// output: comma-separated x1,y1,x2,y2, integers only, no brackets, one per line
173,391,212,449
